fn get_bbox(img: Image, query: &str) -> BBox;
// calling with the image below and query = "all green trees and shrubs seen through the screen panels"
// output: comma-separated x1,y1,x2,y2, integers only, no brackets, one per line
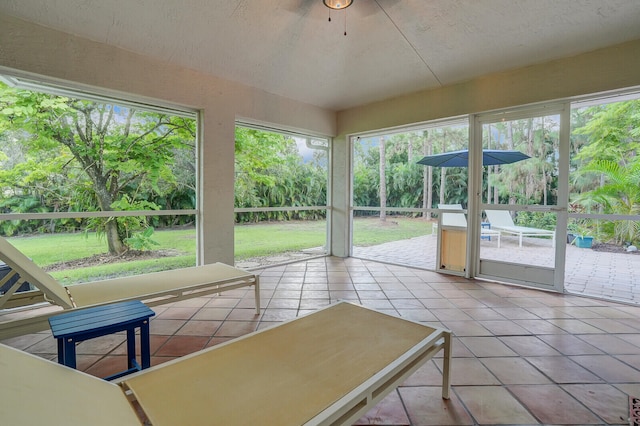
0,80,640,255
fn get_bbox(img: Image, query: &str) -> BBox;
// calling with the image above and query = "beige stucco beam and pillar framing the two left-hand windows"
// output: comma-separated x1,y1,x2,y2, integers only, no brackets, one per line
0,14,336,264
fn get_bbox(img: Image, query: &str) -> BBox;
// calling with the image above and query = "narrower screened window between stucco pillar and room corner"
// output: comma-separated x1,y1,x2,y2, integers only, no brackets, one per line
235,123,330,268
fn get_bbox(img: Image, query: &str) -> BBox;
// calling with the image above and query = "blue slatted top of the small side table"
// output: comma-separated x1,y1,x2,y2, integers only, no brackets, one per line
49,300,156,339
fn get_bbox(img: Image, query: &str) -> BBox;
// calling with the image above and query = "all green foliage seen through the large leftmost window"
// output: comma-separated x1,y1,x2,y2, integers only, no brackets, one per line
0,81,195,253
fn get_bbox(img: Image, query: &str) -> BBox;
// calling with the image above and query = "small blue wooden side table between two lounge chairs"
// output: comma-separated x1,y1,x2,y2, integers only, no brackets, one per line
49,300,155,380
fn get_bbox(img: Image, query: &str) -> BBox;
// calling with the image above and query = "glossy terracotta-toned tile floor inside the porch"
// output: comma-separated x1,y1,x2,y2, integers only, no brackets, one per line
3,257,640,425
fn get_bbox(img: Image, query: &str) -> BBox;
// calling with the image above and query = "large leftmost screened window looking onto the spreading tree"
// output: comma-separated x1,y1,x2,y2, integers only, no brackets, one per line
0,77,198,284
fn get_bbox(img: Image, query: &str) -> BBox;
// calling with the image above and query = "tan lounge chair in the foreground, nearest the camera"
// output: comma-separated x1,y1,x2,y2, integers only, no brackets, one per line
0,302,451,426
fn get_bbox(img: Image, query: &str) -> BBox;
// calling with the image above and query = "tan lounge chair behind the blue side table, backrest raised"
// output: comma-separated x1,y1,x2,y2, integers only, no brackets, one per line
0,237,260,339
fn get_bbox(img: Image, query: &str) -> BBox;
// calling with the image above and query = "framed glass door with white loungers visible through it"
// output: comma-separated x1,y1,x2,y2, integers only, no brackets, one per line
470,105,569,291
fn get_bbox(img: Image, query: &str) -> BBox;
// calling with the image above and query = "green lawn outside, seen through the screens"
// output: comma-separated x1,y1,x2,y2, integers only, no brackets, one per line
9,217,431,284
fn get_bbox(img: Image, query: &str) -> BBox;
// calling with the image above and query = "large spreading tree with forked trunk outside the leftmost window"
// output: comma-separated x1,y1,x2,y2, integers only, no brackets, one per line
0,86,195,254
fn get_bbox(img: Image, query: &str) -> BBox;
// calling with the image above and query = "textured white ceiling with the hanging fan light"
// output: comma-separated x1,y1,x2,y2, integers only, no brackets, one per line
0,0,640,110
